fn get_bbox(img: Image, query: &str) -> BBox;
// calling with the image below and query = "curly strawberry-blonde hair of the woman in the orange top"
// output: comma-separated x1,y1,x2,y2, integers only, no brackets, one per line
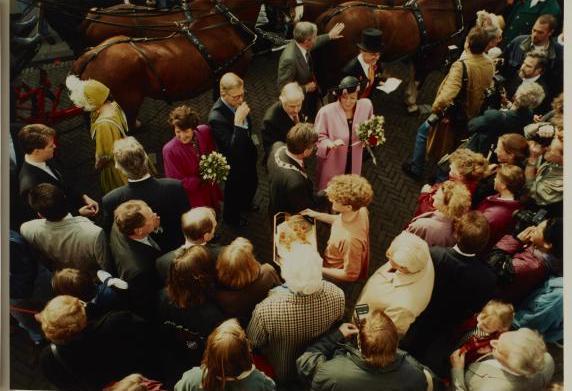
326,174,373,210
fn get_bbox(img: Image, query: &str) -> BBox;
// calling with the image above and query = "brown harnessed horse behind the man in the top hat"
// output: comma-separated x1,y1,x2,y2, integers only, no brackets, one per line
315,0,506,97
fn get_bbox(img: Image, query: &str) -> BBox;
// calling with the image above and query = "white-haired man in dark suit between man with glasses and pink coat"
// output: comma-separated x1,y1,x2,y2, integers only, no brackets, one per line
262,82,305,165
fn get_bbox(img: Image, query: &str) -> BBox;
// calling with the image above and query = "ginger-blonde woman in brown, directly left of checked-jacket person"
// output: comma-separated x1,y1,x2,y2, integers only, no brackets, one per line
215,237,281,326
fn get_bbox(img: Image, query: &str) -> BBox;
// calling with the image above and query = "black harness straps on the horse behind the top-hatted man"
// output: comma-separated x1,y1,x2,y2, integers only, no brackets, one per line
323,0,465,57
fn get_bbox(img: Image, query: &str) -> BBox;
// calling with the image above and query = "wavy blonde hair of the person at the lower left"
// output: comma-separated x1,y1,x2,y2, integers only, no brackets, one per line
36,295,87,344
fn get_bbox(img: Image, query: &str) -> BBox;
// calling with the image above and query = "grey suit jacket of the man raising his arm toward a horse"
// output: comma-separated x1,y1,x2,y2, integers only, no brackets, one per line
277,34,330,90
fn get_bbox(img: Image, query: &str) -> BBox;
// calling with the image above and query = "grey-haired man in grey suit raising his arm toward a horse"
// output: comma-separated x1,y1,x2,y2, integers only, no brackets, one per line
278,22,344,121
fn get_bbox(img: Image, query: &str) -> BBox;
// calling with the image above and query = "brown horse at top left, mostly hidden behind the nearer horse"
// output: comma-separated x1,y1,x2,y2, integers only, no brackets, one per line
82,0,293,45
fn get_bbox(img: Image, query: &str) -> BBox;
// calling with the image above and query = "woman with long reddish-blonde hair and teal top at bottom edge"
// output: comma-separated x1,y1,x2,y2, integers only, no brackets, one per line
175,319,276,391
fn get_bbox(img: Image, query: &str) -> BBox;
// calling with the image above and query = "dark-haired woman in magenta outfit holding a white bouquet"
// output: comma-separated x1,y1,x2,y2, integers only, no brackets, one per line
163,105,223,213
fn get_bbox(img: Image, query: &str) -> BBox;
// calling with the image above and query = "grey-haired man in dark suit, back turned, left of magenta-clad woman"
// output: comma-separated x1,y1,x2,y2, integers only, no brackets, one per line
102,137,190,253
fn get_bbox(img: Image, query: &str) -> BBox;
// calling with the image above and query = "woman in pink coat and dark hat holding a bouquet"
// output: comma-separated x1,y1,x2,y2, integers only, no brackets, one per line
314,76,373,190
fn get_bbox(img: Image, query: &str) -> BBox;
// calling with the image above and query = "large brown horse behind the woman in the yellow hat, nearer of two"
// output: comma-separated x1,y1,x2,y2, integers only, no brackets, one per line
71,0,295,126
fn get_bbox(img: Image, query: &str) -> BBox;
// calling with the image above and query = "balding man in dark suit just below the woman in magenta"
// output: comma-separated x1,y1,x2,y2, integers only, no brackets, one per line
155,206,221,284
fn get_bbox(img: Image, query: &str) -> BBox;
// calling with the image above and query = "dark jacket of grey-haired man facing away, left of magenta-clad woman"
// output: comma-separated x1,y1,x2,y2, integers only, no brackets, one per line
102,177,190,253
